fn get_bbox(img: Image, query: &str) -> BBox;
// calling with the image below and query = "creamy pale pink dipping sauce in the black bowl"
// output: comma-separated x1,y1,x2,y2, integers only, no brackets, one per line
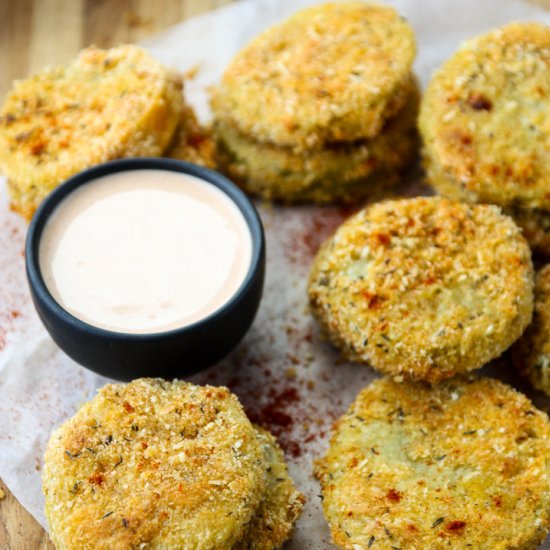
39,170,252,334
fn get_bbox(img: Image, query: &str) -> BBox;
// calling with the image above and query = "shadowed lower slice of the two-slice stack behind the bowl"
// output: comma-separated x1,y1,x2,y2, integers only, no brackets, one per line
214,83,419,203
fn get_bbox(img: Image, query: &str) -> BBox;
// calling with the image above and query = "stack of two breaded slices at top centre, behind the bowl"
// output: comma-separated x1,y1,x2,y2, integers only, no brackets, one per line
212,2,418,203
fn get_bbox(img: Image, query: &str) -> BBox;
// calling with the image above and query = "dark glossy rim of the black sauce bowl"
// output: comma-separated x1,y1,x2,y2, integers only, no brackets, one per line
25,157,265,342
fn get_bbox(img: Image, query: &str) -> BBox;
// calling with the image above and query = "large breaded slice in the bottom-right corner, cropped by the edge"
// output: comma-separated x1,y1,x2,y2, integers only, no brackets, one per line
316,377,550,550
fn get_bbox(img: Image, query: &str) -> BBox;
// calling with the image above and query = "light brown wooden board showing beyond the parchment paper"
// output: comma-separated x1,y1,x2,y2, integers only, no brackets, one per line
0,0,550,550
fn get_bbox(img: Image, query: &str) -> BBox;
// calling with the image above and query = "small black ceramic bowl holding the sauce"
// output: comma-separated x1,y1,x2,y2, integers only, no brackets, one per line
25,158,265,380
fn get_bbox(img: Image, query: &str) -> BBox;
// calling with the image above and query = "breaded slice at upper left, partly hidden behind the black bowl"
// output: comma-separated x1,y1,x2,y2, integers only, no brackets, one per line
0,45,183,219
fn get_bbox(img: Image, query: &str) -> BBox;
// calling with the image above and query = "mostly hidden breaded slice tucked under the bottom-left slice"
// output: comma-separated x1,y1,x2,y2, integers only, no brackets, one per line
237,426,305,550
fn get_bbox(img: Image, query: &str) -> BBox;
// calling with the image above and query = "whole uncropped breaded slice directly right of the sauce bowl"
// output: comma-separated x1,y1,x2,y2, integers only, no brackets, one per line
309,197,534,382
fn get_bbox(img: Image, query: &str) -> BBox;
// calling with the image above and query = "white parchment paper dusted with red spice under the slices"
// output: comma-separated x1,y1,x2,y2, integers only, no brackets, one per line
0,0,550,550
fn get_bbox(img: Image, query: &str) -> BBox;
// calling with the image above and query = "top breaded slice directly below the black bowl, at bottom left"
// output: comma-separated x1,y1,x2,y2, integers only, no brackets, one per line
43,379,266,550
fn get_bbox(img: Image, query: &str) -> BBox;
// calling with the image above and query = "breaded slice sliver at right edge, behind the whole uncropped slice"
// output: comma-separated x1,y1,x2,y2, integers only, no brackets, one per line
512,265,550,395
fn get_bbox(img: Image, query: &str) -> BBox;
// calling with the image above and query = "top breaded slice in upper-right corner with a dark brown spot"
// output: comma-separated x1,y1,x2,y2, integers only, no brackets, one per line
419,23,550,210
